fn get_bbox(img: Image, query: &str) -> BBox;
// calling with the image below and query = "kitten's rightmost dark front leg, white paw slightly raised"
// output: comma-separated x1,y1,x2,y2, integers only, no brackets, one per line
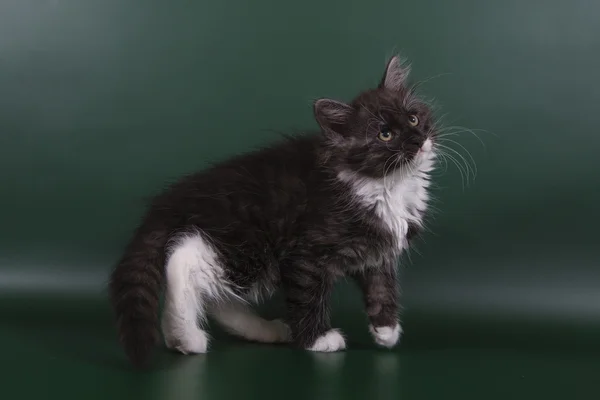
353,264,402,348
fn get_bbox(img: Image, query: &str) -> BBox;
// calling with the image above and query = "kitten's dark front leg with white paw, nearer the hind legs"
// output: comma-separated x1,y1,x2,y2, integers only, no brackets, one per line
281,262,346,352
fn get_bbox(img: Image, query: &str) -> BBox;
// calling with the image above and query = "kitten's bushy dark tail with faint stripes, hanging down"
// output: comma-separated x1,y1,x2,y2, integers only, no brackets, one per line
110,223,168,368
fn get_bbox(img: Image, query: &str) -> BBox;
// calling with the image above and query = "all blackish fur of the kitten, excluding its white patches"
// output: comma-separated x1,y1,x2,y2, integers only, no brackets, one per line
110,54,435,366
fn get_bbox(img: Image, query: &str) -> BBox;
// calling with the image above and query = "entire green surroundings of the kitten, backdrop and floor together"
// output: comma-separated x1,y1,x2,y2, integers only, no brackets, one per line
0,0,600,399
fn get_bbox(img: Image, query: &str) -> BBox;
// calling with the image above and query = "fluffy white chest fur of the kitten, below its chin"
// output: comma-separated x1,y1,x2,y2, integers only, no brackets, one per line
338,140,435,251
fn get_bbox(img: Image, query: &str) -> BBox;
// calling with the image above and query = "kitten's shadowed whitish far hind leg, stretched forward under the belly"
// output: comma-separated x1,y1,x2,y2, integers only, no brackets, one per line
210,300,291,343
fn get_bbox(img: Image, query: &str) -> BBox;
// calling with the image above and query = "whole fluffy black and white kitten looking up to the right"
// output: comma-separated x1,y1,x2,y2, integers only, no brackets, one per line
110,57,436,366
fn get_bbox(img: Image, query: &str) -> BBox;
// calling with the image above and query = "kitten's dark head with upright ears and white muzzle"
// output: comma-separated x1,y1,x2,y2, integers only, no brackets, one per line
314,57,435,178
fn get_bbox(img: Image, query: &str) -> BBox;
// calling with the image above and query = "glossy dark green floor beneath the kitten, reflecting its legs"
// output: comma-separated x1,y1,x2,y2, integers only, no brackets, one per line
0,298,600,400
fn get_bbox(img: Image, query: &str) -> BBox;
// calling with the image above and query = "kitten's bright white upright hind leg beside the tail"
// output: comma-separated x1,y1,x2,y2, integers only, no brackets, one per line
162,235,225,354
